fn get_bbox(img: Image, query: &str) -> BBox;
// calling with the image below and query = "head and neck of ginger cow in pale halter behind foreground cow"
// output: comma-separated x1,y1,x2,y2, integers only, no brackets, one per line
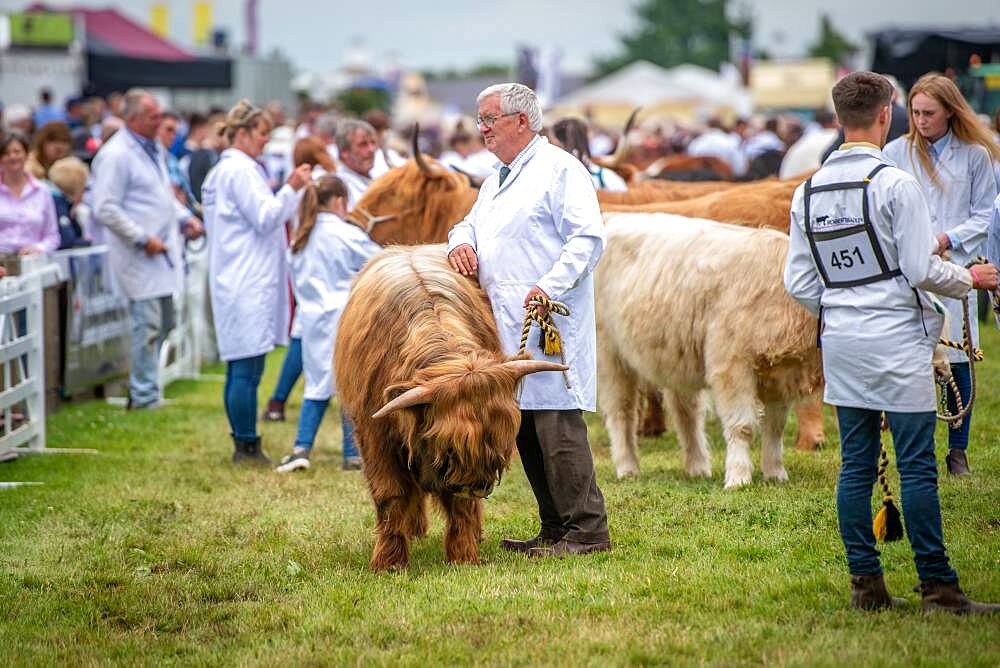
348,156,479,246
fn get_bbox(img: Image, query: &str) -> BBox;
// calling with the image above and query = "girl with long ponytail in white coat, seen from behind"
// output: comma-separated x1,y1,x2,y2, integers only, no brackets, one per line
275,174,381,473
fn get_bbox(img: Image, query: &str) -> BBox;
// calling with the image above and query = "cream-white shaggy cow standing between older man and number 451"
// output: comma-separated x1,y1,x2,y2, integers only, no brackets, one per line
595,213,823,489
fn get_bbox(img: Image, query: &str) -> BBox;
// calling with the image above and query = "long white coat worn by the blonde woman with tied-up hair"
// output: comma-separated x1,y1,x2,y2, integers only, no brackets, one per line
202,148,299,362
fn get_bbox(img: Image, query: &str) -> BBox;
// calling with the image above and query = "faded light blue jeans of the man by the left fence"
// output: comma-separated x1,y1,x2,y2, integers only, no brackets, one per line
128,295,174,408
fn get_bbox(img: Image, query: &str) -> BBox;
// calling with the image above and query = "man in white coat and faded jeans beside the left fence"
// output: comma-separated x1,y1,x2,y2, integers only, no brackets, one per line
93,89,200,409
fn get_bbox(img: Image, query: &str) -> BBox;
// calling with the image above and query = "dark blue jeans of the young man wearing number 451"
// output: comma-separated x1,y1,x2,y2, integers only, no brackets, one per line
837,406,958,582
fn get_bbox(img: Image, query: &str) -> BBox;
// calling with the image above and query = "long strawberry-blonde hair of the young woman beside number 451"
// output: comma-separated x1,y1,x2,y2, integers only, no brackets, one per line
905,72,1000,189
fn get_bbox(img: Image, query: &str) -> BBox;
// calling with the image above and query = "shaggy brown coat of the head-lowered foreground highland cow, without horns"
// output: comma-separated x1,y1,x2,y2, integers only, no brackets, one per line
334,246,521,571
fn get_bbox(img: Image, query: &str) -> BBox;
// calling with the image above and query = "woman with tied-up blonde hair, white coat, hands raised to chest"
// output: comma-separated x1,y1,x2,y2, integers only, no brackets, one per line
202,100,310,464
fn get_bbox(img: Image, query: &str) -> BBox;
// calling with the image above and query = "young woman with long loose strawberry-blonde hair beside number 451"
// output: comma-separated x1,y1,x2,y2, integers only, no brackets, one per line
885,74,1000,475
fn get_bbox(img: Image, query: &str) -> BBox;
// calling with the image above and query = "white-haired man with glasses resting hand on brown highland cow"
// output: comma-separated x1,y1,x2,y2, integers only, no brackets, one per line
448,84,611,556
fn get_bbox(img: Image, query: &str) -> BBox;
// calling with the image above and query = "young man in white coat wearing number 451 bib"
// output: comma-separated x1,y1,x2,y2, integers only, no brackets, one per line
785,72,1000,614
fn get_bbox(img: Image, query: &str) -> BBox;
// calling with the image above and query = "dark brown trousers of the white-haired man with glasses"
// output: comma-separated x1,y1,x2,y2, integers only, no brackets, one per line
517,410,610,543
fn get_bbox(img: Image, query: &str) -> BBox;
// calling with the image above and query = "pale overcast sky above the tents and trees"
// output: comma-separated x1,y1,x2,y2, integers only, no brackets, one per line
0,0,1000,72
